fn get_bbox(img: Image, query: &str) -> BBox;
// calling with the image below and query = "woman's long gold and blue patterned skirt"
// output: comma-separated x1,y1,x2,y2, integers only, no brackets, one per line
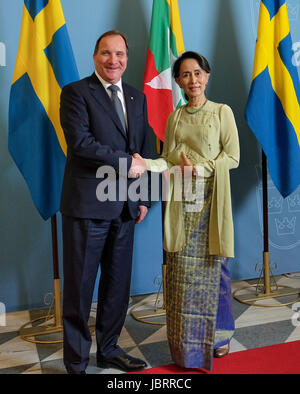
165,177,234,370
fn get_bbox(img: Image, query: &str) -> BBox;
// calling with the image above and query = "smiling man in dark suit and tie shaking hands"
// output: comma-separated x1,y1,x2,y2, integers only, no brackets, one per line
61,31,150,374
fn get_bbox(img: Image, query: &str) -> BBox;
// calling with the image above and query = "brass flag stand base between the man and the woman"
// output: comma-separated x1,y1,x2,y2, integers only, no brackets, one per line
130,264,166,326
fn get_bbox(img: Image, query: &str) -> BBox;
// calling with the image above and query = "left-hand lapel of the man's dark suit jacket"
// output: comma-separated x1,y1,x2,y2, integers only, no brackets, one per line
89,73,127,139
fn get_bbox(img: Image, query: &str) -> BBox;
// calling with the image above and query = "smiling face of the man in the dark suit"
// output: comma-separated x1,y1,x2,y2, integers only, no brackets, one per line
94,35,128,84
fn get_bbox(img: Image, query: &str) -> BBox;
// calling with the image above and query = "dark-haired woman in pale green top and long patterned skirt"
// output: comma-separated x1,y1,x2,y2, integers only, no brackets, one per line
135,52,239,369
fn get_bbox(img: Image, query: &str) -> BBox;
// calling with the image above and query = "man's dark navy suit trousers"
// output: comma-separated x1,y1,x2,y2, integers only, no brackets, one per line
62,204,135,372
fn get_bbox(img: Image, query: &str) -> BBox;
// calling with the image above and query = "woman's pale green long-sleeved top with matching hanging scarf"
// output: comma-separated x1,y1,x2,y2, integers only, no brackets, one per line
146,100,240,257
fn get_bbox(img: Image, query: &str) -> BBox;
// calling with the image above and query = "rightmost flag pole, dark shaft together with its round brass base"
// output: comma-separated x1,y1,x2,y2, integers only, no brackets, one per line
233,149,300,307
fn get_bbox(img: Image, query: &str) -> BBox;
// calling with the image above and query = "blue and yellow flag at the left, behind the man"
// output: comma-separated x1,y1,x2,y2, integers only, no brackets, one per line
8,0,79,220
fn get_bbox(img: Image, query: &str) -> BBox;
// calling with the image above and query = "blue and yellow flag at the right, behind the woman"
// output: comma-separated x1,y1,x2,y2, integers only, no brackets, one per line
246,0,300,197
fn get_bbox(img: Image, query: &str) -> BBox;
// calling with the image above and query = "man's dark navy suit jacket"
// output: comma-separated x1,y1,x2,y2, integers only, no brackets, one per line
60,73,150,220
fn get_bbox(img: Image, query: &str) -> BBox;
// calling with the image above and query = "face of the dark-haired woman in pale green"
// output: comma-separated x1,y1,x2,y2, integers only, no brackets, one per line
176,59,209,99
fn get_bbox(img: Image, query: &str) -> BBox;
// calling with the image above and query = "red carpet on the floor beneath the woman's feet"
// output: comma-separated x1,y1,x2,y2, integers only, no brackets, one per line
135,341,300,374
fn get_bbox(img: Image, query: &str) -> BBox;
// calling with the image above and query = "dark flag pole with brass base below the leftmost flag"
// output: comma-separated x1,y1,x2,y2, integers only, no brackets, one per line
20,214,63,343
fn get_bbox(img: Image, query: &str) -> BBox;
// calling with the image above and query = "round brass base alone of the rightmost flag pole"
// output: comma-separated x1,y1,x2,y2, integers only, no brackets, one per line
233,252,300,307
